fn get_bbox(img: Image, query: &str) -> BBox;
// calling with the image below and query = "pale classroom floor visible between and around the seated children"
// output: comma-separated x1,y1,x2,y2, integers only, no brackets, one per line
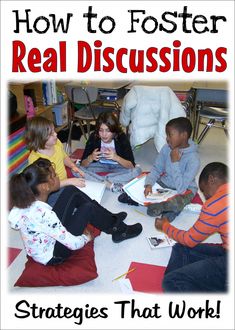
8,122,229,294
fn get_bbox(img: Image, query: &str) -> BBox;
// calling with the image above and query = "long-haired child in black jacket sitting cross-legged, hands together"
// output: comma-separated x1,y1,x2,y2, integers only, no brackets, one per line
73,112,141,192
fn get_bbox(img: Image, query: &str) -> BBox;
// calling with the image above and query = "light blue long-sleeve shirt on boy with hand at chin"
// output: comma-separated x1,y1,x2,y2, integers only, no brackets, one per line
145,139,200,194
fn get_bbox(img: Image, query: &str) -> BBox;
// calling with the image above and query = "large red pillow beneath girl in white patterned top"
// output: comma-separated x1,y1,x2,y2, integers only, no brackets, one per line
15,226,100,287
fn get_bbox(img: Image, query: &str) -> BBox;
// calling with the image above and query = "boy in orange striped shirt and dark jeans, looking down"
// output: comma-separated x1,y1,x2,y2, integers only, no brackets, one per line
155,162,229,292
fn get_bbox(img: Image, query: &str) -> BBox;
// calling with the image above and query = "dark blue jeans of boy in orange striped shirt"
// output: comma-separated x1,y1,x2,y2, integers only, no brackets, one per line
162,243,228,293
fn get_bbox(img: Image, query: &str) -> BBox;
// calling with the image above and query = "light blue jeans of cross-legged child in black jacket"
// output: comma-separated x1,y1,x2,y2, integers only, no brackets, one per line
72,162,142,184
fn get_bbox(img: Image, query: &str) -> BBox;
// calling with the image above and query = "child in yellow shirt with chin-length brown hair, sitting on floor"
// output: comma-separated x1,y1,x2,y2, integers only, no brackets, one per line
25,116,85,206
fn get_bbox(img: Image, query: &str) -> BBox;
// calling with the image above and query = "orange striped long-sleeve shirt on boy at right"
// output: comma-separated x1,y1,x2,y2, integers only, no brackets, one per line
162,183,229,249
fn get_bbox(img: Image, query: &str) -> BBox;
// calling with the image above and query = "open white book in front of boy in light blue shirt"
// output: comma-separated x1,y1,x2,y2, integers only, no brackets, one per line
123,173,177,205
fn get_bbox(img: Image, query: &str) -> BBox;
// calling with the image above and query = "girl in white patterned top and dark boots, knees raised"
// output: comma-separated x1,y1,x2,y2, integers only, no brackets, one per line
8,158,142,265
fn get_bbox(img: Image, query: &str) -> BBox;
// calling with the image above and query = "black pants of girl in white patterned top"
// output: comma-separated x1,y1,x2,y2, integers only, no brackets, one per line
47,186,115,265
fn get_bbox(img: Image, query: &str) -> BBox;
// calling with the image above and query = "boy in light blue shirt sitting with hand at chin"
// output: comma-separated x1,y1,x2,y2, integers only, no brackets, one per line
118,117,200,221
